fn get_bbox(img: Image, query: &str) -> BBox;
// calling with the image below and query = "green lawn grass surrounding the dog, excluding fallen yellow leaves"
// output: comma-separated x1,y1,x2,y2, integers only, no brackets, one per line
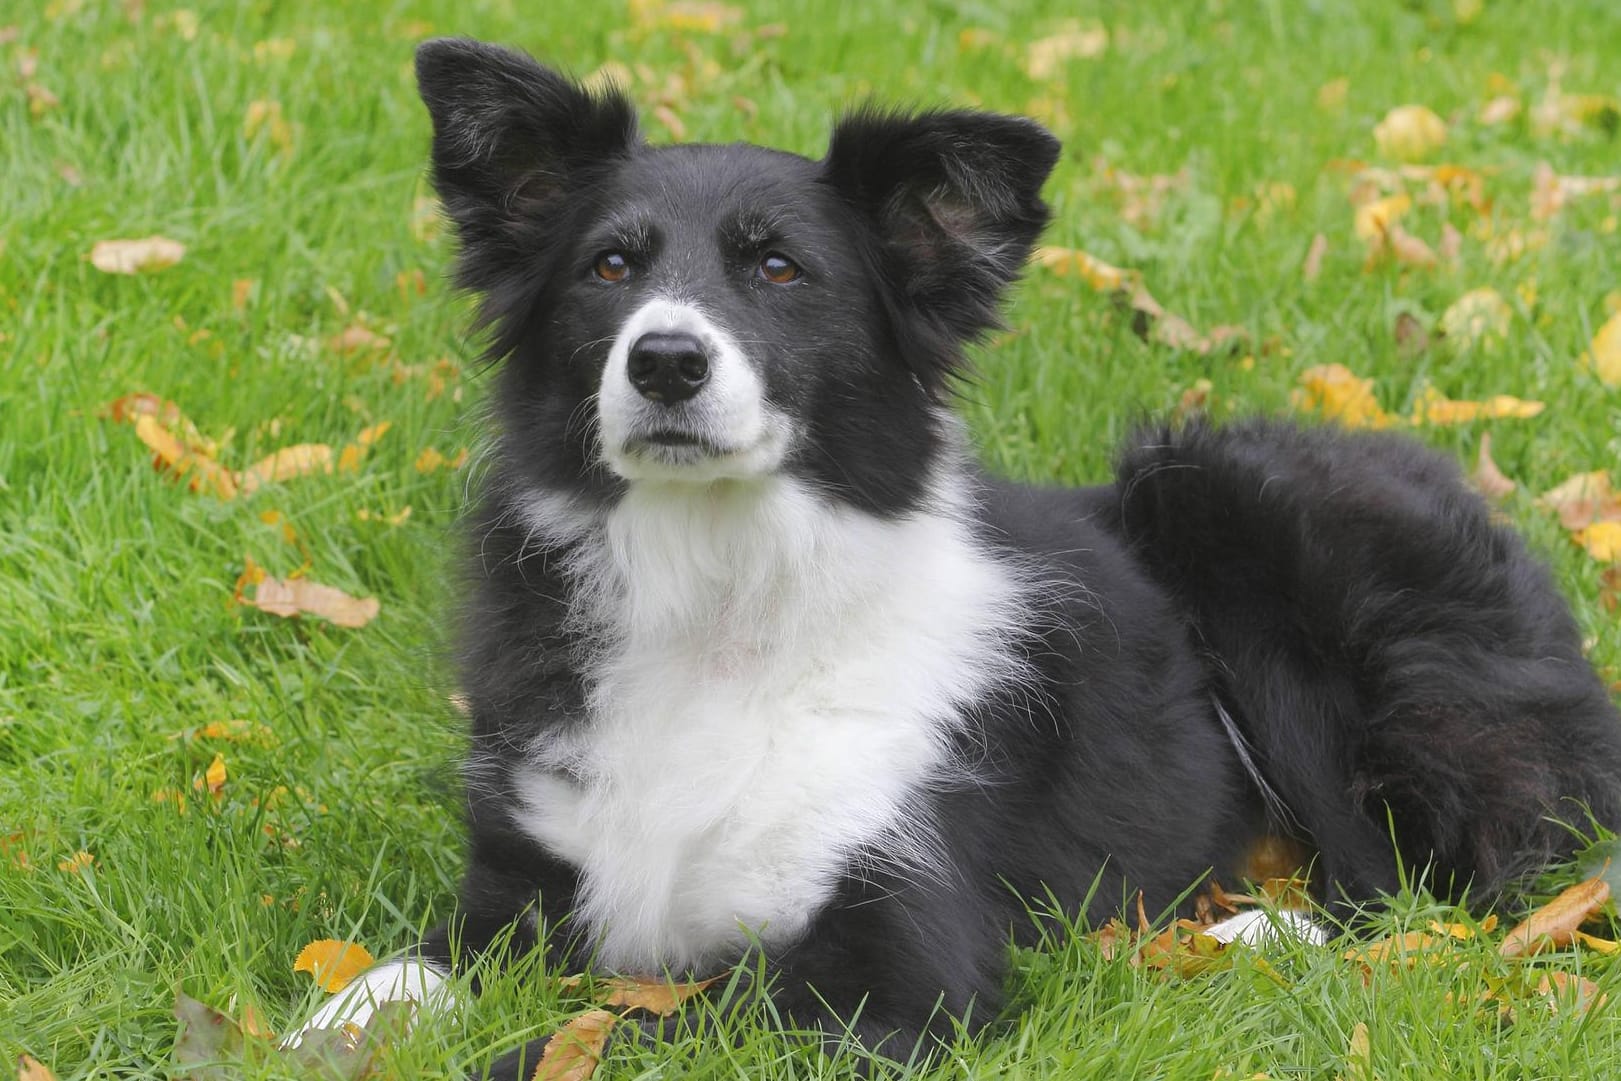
0,0,1621,1081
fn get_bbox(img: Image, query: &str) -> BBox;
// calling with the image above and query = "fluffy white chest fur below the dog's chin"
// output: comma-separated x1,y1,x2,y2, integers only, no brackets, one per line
517,478,1018,974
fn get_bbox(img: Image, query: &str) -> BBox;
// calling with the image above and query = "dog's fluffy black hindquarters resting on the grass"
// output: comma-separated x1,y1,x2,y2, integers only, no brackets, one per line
1110,421,1621,903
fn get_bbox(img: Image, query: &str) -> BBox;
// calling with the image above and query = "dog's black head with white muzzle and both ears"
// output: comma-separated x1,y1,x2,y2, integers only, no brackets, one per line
417,39,1059,514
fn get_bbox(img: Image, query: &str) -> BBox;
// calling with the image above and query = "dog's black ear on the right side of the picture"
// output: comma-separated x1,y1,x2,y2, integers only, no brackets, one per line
823,110,1059,384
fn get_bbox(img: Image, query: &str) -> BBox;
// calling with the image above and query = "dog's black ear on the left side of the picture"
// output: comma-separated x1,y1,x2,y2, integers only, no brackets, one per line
417,37,637,288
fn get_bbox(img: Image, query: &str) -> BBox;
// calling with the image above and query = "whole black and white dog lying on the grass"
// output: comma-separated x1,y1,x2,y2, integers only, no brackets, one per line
295,41,1621,1075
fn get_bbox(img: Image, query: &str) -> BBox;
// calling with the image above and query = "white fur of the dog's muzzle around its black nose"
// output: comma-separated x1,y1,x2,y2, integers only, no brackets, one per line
597,298,793,481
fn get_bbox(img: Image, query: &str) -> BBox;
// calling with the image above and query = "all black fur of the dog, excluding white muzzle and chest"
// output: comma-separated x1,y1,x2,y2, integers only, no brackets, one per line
402,41,1621,1076
